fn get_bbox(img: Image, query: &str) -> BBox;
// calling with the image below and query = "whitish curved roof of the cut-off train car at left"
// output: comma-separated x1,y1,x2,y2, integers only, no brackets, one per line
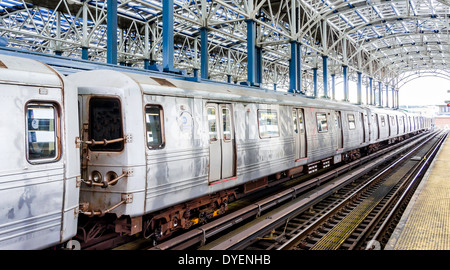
0,55,63,87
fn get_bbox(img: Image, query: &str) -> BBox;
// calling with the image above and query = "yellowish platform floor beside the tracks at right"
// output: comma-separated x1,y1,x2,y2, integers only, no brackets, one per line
385,134,450,250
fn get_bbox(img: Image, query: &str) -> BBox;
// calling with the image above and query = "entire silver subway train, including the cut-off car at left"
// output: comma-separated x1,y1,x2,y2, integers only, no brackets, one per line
0,55,432,249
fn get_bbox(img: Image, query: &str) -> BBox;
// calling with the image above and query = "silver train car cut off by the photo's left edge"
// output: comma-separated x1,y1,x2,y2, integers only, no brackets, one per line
0,55,80,249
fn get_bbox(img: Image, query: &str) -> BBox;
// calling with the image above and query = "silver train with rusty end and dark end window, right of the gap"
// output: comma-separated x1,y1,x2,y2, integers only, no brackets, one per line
69,70,431,239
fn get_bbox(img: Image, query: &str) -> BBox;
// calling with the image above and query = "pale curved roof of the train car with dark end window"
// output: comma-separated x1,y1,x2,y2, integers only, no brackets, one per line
69,70,376,111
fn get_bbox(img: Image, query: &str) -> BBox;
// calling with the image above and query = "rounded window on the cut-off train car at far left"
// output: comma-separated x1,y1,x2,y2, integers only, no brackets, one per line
26,103,61,163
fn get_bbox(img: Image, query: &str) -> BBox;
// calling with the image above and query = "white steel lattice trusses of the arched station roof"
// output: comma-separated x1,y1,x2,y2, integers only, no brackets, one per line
0,0,450,98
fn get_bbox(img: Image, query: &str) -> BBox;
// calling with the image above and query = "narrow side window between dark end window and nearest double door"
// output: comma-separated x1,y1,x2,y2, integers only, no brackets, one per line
145,105,164,149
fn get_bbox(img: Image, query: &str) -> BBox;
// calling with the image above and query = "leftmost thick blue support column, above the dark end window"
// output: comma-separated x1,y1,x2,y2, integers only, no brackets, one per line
106,0,118,65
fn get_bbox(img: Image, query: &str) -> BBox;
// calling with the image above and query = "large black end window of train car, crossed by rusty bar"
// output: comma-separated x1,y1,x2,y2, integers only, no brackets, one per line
89,97,124,151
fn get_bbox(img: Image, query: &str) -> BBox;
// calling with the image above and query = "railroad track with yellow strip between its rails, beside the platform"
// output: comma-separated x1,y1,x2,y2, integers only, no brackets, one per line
276,130,446,250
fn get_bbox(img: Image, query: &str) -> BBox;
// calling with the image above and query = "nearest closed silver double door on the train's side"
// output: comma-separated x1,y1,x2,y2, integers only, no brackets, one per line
206,103,235,182
